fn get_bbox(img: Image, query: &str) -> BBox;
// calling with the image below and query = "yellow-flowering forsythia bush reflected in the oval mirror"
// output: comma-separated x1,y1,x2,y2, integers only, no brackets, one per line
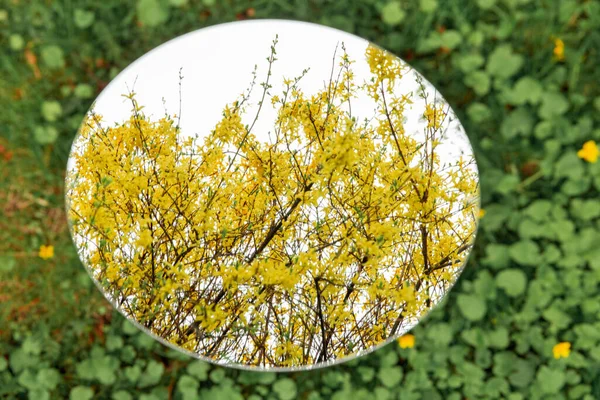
68,42,478,366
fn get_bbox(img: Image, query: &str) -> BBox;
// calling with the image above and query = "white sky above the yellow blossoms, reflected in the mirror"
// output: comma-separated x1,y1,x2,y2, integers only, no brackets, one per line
76,20,473,169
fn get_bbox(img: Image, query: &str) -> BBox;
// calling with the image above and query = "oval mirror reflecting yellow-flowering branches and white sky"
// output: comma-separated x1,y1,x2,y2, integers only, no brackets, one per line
67,20,479,369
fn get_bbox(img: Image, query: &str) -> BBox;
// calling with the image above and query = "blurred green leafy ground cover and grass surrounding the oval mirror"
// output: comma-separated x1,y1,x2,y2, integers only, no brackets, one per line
0,0,600,400
